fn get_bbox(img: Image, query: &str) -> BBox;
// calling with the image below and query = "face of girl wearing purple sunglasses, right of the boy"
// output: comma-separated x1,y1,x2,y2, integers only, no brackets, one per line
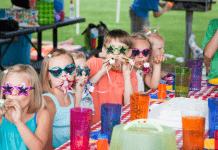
133,39,150,68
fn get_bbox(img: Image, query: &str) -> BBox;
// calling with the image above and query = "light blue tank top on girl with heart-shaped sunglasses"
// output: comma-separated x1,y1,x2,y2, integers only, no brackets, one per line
43,92,74,148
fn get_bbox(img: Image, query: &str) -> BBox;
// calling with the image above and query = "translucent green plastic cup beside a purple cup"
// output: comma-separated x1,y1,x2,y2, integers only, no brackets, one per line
175,67,191,97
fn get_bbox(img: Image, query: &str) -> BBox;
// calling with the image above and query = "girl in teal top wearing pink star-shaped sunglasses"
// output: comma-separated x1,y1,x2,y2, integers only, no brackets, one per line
0,64,50,150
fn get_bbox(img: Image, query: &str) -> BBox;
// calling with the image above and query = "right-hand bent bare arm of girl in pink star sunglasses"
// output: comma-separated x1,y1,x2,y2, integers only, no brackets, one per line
11,100,50,150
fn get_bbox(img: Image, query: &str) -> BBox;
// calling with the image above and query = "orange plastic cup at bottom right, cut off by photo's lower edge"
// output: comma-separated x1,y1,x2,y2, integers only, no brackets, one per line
182,116,205,150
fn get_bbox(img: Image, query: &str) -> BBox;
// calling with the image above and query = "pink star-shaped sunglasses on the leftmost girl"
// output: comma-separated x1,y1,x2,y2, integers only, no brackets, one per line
1,82,34,96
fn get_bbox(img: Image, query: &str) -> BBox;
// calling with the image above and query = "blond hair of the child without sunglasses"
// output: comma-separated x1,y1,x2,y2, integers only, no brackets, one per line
143,26,165,48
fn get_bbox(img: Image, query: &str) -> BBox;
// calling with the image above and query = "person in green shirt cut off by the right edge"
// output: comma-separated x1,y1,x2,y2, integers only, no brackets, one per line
202,19,218,79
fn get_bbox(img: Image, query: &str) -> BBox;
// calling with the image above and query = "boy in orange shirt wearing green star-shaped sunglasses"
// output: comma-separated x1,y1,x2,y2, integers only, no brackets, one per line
87,29,138,123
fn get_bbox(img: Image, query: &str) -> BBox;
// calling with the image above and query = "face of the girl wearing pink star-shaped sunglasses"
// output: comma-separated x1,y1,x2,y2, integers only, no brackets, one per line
5,72,31,109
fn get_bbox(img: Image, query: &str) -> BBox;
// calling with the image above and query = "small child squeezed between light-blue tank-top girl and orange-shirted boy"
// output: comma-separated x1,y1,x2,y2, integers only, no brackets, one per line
71,51,95,115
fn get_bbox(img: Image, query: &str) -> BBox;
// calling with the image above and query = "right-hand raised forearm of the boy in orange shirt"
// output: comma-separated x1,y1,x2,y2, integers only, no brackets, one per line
122,62,133,105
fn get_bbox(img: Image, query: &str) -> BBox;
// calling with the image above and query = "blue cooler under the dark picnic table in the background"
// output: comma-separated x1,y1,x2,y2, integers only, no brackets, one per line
1,34,31,66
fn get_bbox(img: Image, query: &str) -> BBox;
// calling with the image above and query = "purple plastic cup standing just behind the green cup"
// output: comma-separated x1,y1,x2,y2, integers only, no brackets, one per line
188,58,204,91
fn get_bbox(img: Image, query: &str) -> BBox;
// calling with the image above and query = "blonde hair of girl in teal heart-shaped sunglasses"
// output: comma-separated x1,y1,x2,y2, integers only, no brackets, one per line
40,49,75,93
